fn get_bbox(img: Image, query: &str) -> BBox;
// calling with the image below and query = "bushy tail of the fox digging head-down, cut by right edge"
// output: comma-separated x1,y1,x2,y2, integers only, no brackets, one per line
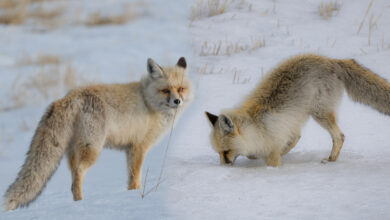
337,60,390,116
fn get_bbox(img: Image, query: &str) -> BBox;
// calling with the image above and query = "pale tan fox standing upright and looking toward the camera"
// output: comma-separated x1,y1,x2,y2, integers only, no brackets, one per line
5,57,192,210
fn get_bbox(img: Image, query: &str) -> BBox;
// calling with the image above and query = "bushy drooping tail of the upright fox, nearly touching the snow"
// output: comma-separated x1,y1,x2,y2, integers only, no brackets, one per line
4,97,78,210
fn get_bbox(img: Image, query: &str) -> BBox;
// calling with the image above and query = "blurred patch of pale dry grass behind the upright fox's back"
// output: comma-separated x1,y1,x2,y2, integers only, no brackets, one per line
0,55,82,112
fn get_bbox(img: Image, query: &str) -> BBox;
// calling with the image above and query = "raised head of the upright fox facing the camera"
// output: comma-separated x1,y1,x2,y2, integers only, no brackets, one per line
143,57,192,112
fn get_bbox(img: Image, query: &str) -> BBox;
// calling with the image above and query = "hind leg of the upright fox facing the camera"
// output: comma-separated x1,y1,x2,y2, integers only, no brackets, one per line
68,144,100,201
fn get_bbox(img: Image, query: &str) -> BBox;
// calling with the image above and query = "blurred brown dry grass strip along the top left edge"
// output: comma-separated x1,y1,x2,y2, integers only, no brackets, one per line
0,0,143,30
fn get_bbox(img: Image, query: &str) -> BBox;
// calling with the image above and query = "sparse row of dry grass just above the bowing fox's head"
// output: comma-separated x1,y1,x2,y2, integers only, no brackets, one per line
199,37,266,56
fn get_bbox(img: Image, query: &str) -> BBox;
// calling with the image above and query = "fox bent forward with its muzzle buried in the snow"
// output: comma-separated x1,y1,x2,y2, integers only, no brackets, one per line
206,54,390,166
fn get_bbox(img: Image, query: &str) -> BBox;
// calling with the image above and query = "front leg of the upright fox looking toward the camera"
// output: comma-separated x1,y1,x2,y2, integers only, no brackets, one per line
126,147,147,190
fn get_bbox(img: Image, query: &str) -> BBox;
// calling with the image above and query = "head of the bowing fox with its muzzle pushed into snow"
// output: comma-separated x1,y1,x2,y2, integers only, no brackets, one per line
206,112,244,165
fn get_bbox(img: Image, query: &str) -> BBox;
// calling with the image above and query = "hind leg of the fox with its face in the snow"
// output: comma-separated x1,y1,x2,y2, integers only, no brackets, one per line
313,111,345,162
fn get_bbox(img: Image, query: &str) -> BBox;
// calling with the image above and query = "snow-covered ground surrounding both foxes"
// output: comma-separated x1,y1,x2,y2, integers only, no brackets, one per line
0,0,390,219
